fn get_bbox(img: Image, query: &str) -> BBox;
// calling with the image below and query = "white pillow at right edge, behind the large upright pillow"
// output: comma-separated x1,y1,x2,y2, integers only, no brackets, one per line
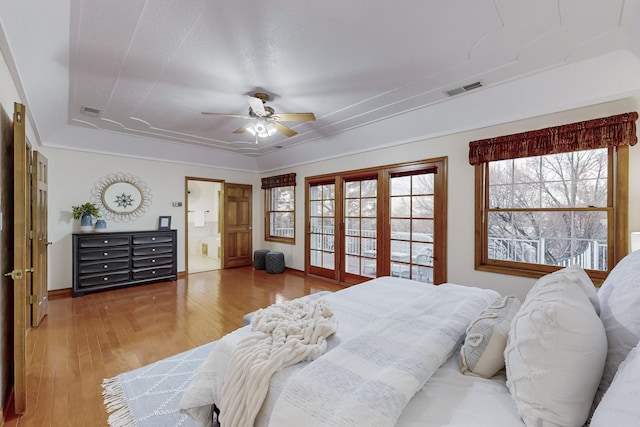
595,251,640,404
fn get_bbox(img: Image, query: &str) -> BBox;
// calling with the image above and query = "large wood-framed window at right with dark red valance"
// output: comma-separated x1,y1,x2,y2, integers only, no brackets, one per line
470,113,637,280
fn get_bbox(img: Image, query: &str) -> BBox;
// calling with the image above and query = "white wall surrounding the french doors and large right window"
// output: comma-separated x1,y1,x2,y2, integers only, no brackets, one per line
262,99,640,299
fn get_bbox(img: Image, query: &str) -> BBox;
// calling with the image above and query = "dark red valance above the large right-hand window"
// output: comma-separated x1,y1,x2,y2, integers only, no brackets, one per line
469,111,638,165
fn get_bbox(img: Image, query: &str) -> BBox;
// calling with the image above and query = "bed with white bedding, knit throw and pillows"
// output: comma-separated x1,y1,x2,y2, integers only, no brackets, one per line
180,251,640,427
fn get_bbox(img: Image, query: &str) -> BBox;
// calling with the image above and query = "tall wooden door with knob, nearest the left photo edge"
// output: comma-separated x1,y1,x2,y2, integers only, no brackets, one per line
11,103,31,414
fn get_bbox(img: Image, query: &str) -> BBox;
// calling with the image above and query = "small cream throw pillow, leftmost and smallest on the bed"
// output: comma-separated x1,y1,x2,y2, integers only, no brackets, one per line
458,296,520,378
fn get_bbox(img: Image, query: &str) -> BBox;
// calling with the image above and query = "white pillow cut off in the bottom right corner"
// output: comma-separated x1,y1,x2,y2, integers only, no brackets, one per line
590,345,640,427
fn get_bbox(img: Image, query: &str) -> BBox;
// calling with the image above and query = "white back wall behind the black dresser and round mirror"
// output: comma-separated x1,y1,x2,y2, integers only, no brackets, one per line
39,147,263,290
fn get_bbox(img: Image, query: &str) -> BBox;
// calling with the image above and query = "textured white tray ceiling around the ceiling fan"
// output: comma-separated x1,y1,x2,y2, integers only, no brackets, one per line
0,0,640,172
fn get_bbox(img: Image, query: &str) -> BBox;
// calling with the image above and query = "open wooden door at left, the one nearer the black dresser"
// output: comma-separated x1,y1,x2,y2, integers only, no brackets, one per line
31,151,49,327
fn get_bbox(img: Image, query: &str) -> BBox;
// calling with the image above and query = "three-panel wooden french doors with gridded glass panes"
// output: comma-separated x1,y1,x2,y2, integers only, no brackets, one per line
305,158,447,284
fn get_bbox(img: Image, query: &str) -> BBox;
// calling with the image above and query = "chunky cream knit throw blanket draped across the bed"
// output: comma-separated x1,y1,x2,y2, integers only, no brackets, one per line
218,298,336,427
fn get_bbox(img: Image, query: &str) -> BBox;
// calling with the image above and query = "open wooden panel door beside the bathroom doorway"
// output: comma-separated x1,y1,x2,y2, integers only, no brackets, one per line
222,183,253,268
